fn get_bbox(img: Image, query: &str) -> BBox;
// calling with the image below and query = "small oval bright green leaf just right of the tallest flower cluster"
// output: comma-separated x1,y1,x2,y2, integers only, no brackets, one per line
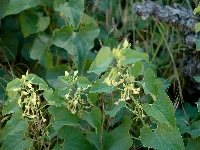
129,61,144,77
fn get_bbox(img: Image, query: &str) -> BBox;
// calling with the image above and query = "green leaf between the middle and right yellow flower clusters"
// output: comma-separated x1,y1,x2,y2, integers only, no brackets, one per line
90,73,116,94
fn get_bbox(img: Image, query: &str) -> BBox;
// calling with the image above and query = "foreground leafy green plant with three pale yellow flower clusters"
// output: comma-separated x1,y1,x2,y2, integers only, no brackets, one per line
2,41,188,150
